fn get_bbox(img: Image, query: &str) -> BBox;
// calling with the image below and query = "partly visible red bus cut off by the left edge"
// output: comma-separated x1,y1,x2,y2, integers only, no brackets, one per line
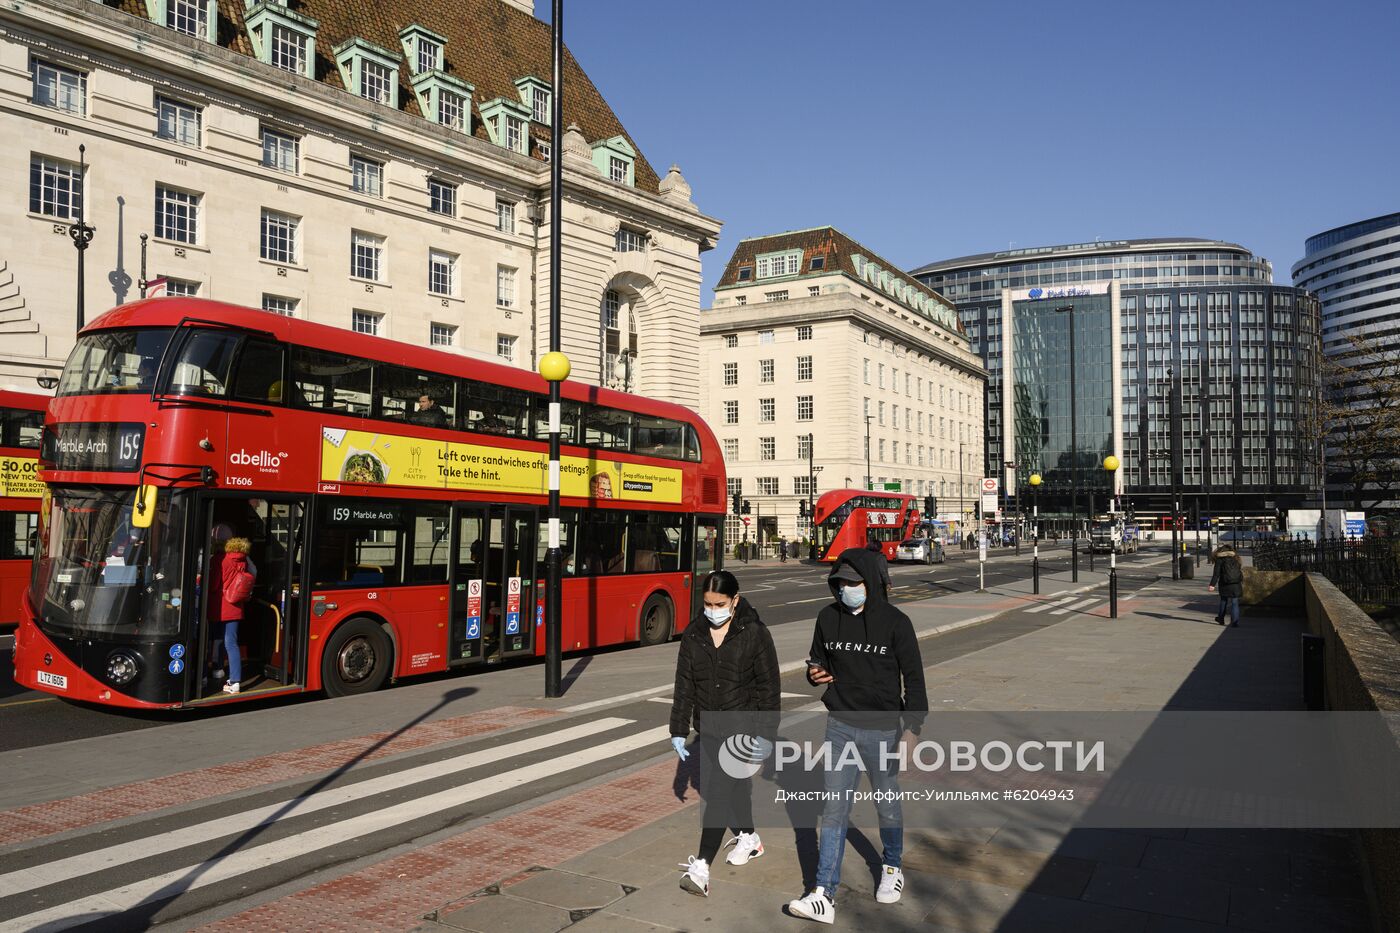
0,391,49,632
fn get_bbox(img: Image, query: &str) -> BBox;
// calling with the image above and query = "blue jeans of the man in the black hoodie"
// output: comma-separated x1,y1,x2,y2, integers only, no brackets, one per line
816,717,904,897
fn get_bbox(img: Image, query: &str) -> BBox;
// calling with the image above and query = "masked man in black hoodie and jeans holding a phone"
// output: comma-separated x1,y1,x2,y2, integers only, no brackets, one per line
788,548,928,923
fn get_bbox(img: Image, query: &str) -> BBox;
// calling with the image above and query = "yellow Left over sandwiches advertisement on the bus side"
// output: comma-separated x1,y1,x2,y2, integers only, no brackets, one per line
321,427,682,503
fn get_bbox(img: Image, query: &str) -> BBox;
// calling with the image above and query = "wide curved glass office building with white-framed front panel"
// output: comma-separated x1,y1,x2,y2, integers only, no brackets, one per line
913,238,1319,521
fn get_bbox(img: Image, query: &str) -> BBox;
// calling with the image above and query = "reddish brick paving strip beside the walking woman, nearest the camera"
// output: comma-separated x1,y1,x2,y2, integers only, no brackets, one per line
199,761,694,933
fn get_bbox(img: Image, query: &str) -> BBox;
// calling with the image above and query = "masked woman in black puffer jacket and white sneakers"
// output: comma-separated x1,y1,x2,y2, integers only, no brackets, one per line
671,570,781,897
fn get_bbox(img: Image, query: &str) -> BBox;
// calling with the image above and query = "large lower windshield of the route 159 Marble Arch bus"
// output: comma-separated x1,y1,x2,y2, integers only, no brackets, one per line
34,488,188,636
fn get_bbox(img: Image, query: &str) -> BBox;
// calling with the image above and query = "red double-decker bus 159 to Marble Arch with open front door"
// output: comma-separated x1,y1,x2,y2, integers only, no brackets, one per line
14,298,725,707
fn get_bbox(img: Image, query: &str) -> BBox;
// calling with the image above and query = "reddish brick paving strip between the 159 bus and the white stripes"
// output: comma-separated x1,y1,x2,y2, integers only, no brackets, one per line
0,706,556,846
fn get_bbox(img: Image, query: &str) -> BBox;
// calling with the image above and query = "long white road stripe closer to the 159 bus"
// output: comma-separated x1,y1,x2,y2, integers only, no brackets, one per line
0,717,636,896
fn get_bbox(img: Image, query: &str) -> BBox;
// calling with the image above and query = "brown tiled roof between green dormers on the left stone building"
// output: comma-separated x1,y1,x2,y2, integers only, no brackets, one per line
108,0,659,193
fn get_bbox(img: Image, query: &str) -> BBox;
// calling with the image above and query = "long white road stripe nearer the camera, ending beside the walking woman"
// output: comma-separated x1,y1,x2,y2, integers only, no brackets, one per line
4,726,671,932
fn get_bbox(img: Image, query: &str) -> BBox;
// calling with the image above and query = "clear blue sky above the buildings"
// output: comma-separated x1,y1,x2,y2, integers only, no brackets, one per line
536,0,1400,298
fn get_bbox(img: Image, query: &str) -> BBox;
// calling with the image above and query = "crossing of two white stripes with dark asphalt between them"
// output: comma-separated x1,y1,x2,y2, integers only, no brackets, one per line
0,716,669,932
